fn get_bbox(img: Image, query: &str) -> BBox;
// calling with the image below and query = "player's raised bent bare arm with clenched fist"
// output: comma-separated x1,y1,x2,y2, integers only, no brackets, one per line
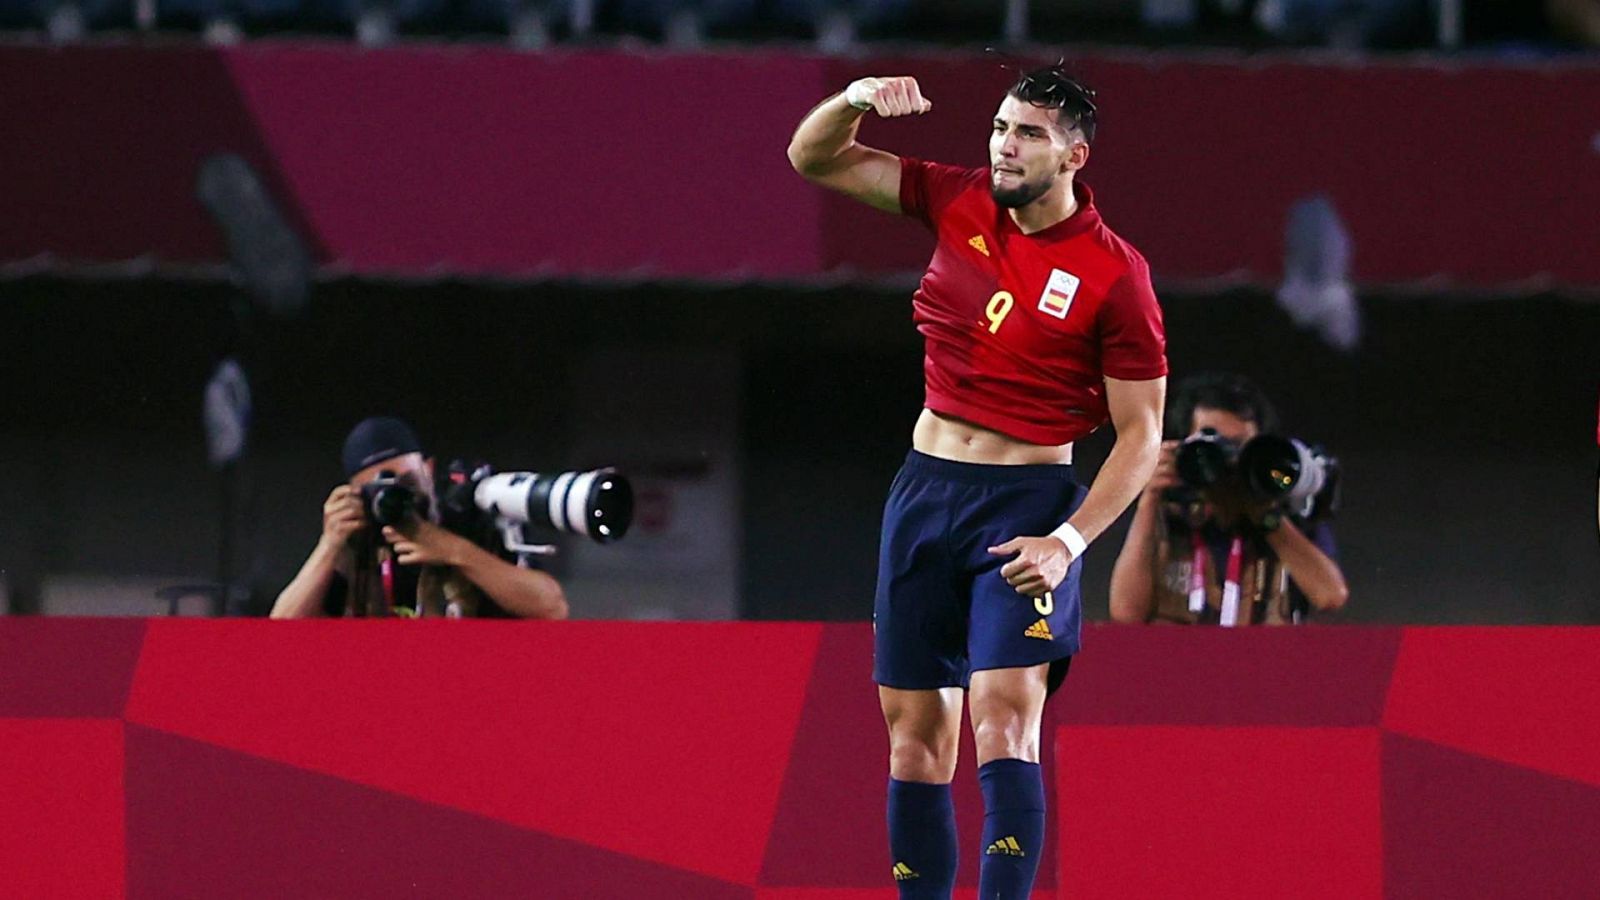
789,75,933,213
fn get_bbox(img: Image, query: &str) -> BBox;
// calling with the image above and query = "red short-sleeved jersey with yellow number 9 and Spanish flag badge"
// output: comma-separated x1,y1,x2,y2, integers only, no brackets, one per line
899,159,1166,445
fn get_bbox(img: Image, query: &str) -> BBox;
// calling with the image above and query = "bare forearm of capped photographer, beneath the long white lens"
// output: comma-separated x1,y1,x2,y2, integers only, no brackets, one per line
384,522,566,618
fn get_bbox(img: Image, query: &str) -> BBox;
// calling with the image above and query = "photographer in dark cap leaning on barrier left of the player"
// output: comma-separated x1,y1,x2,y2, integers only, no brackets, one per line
272,418,566,618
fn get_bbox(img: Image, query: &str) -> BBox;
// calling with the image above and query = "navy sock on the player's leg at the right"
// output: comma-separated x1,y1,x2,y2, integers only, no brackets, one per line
978,759,1045,900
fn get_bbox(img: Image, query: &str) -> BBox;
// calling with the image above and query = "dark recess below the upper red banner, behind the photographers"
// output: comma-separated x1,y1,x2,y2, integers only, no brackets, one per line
0,277,1600,623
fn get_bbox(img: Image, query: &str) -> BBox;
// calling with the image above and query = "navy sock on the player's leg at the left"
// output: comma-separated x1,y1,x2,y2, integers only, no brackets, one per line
890,778,960,900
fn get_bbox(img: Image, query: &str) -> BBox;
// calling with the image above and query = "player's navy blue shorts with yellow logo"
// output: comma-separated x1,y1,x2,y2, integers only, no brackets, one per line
872,450,1086,690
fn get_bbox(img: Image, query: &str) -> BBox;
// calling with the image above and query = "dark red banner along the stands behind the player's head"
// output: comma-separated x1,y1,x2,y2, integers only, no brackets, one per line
0,43,1600,285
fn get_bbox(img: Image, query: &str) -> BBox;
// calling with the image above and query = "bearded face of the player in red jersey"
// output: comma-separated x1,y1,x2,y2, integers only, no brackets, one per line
989,94,1088,208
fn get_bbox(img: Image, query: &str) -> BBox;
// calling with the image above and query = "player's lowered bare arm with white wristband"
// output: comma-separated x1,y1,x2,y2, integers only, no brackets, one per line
989,376,1166,597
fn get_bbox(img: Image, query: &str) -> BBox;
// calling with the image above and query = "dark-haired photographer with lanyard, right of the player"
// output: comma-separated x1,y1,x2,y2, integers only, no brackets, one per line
1110,375,1349,625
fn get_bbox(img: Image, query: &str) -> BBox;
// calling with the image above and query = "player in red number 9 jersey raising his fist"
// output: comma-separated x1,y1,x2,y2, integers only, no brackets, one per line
789,66,1166,900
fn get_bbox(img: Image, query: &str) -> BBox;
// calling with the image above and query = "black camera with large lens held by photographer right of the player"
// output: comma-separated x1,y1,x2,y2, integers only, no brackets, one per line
1166,428,1341,519
